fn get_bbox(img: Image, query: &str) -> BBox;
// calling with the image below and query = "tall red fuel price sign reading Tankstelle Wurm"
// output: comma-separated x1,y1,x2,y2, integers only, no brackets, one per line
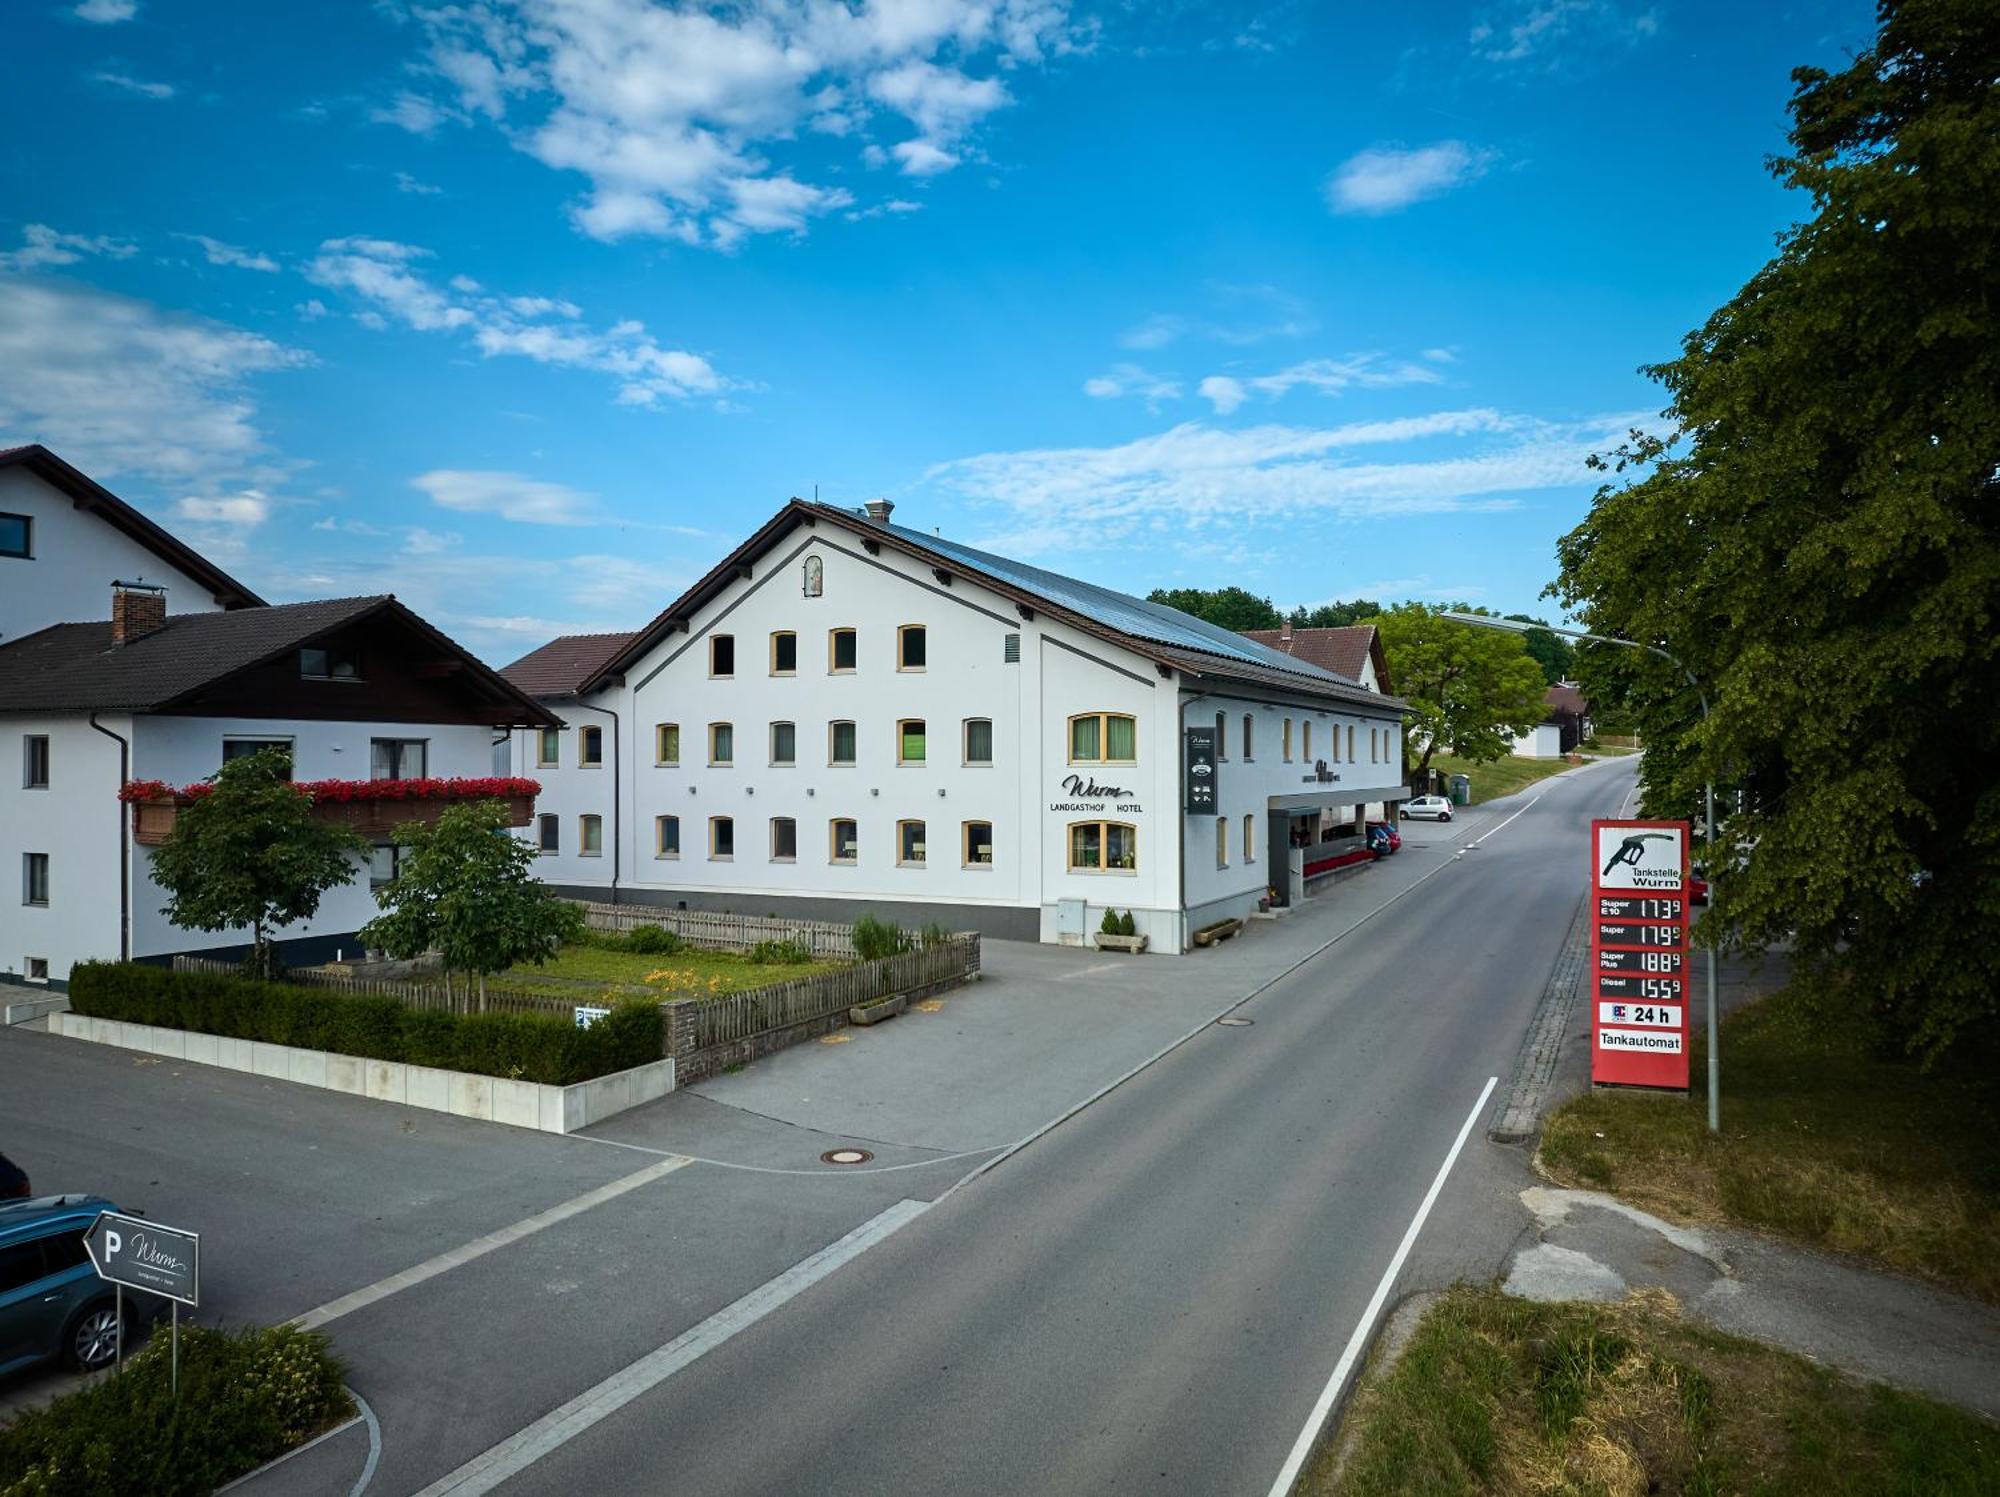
1586,821,1688,1091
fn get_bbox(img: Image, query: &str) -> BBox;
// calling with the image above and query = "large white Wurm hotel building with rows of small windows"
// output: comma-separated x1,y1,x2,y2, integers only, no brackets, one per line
502,500,1408,951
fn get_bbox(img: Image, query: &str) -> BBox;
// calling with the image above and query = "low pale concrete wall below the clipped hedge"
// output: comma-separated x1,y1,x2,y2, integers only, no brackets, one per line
48,1013,674,1133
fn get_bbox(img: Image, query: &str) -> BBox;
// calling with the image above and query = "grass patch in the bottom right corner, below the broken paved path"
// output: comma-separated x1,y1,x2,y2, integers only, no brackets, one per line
1300,1287,2000,1497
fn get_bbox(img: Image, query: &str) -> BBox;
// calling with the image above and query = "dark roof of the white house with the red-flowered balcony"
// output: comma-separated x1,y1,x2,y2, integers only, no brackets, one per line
0,594,554,724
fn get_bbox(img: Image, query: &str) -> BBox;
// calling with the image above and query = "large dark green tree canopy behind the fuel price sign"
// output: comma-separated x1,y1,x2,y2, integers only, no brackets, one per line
1558,0,2000,1053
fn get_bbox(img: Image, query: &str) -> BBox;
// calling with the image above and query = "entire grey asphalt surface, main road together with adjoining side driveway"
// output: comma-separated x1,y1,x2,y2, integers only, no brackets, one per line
0,765,1632,1497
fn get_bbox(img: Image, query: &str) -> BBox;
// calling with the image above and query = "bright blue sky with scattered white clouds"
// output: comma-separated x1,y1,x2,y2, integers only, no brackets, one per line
0,0,1872,660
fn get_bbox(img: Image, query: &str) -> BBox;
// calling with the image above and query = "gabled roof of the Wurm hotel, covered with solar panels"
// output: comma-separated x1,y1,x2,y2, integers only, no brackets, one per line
578,498,1402,710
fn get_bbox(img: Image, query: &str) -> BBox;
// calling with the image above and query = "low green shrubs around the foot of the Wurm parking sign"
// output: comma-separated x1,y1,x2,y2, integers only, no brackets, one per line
0,1325,354,1497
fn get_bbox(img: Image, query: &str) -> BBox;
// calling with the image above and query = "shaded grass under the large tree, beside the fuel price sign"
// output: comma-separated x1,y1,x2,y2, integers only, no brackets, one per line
1542,985,2000,1303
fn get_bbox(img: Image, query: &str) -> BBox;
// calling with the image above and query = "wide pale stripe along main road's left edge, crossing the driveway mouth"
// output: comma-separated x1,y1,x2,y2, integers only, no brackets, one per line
416,1201,930,1497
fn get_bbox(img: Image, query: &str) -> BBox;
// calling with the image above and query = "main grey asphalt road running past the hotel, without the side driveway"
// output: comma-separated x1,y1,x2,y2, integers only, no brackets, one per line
472,767,1632,1497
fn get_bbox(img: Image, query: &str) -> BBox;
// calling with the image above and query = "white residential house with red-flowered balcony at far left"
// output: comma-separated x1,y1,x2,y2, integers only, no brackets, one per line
0,448,556,989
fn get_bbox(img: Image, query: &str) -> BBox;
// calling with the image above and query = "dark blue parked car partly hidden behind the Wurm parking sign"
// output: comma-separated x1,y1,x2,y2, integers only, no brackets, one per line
0,1195,160,1373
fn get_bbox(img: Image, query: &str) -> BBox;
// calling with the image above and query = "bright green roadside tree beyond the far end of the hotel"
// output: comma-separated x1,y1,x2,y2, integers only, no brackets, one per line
1366,602,1548,775
